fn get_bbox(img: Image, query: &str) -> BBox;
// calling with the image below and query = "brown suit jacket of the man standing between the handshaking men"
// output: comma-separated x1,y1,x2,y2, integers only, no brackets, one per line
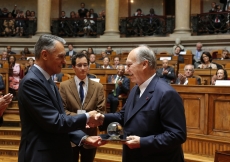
59,78,105,136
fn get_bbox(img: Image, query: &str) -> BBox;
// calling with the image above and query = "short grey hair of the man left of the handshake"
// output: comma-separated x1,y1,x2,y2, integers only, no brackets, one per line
34,34,66,59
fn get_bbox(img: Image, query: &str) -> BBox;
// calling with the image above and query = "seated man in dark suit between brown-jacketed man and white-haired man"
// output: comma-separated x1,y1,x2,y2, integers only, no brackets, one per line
107,65,130,113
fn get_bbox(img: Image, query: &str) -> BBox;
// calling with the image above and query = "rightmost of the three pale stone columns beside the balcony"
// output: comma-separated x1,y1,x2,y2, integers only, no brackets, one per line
173,0,191,35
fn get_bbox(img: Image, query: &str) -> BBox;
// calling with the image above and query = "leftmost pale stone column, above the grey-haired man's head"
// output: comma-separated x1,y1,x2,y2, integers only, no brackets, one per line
36,0,51,35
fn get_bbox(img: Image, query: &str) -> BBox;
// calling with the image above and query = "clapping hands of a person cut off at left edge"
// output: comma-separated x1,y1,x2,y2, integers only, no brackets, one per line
0,93,13,125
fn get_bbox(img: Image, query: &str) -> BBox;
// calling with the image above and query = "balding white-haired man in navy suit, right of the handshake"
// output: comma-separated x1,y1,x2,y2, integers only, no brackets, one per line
98,45,186,162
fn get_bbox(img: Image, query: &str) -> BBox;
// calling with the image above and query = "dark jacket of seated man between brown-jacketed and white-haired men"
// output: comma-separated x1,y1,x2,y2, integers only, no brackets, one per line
108,75,130,96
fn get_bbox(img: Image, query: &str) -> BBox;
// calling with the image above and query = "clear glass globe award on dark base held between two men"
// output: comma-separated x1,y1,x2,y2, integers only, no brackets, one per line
100,122,127,141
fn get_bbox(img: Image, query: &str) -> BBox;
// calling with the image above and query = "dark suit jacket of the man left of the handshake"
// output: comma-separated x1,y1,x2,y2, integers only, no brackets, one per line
18,66,87,162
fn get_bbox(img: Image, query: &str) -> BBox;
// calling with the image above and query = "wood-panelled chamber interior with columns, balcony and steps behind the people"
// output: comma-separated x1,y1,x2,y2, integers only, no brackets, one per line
0,0,230,162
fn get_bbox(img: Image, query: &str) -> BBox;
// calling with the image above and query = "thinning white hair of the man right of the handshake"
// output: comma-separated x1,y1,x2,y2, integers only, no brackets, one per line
137,45,157,69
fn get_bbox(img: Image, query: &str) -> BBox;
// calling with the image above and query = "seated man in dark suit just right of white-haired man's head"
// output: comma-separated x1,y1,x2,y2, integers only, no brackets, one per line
156,59,175,84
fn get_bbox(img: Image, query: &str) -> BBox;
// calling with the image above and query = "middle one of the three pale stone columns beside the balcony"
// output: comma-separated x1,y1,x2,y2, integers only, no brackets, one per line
103,0,120,36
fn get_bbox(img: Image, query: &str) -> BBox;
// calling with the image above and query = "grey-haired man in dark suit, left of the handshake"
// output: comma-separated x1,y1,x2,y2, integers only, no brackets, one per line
18,35,104,162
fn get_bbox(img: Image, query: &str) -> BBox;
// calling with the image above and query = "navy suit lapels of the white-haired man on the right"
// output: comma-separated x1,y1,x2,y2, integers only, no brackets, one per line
125,75,159,123
